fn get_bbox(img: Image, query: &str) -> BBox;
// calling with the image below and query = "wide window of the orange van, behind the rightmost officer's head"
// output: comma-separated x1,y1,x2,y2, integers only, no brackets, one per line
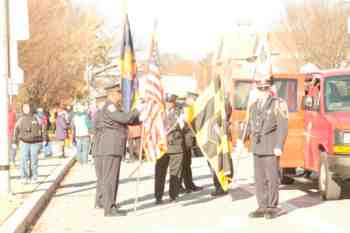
234,78,298,112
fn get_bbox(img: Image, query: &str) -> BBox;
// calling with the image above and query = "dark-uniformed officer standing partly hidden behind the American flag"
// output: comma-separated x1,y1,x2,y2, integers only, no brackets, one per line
154,95,184,204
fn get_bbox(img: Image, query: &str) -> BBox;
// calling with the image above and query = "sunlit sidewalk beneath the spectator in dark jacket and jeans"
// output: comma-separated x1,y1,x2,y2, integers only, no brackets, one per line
0,142,76,226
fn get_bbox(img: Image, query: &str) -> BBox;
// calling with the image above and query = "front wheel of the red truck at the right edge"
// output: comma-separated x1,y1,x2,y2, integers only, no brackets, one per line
318,152,341,200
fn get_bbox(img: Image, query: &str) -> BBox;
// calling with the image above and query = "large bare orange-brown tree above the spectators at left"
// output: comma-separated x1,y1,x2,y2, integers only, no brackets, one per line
18,0,111,107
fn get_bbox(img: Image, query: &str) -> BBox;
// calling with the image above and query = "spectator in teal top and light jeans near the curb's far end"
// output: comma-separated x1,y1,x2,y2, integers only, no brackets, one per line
72,104,92,165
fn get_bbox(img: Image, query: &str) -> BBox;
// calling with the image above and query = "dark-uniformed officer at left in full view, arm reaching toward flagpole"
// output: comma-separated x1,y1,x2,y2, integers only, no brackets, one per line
96,84,139,216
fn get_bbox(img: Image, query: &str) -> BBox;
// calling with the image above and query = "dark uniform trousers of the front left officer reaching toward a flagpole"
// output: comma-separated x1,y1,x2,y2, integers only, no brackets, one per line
102,155,122,212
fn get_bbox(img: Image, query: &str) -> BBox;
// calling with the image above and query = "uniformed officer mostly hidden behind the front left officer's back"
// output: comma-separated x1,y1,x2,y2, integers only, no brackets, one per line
92,95,107,208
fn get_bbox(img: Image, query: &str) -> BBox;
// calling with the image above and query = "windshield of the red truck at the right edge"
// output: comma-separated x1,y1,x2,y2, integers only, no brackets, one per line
324,76,350,112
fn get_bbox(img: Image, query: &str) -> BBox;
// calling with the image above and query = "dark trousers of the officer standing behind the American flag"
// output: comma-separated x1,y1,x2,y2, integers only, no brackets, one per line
154,153,183,200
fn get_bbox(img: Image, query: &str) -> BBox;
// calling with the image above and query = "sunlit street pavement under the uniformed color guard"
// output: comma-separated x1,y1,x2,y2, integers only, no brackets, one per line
31,158,350,233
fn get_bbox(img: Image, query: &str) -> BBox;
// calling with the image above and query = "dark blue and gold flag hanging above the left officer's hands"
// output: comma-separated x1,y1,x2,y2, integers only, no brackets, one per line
119,15,138,112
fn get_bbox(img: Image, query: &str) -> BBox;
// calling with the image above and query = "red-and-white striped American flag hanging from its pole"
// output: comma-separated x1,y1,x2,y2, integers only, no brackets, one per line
142,21,167,161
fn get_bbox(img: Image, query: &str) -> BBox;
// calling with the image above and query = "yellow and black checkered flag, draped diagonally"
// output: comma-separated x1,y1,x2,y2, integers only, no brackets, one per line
186,78,231,191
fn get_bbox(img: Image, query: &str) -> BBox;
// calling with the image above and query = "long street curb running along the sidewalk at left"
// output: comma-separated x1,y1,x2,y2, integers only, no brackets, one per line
0,156,75,233
